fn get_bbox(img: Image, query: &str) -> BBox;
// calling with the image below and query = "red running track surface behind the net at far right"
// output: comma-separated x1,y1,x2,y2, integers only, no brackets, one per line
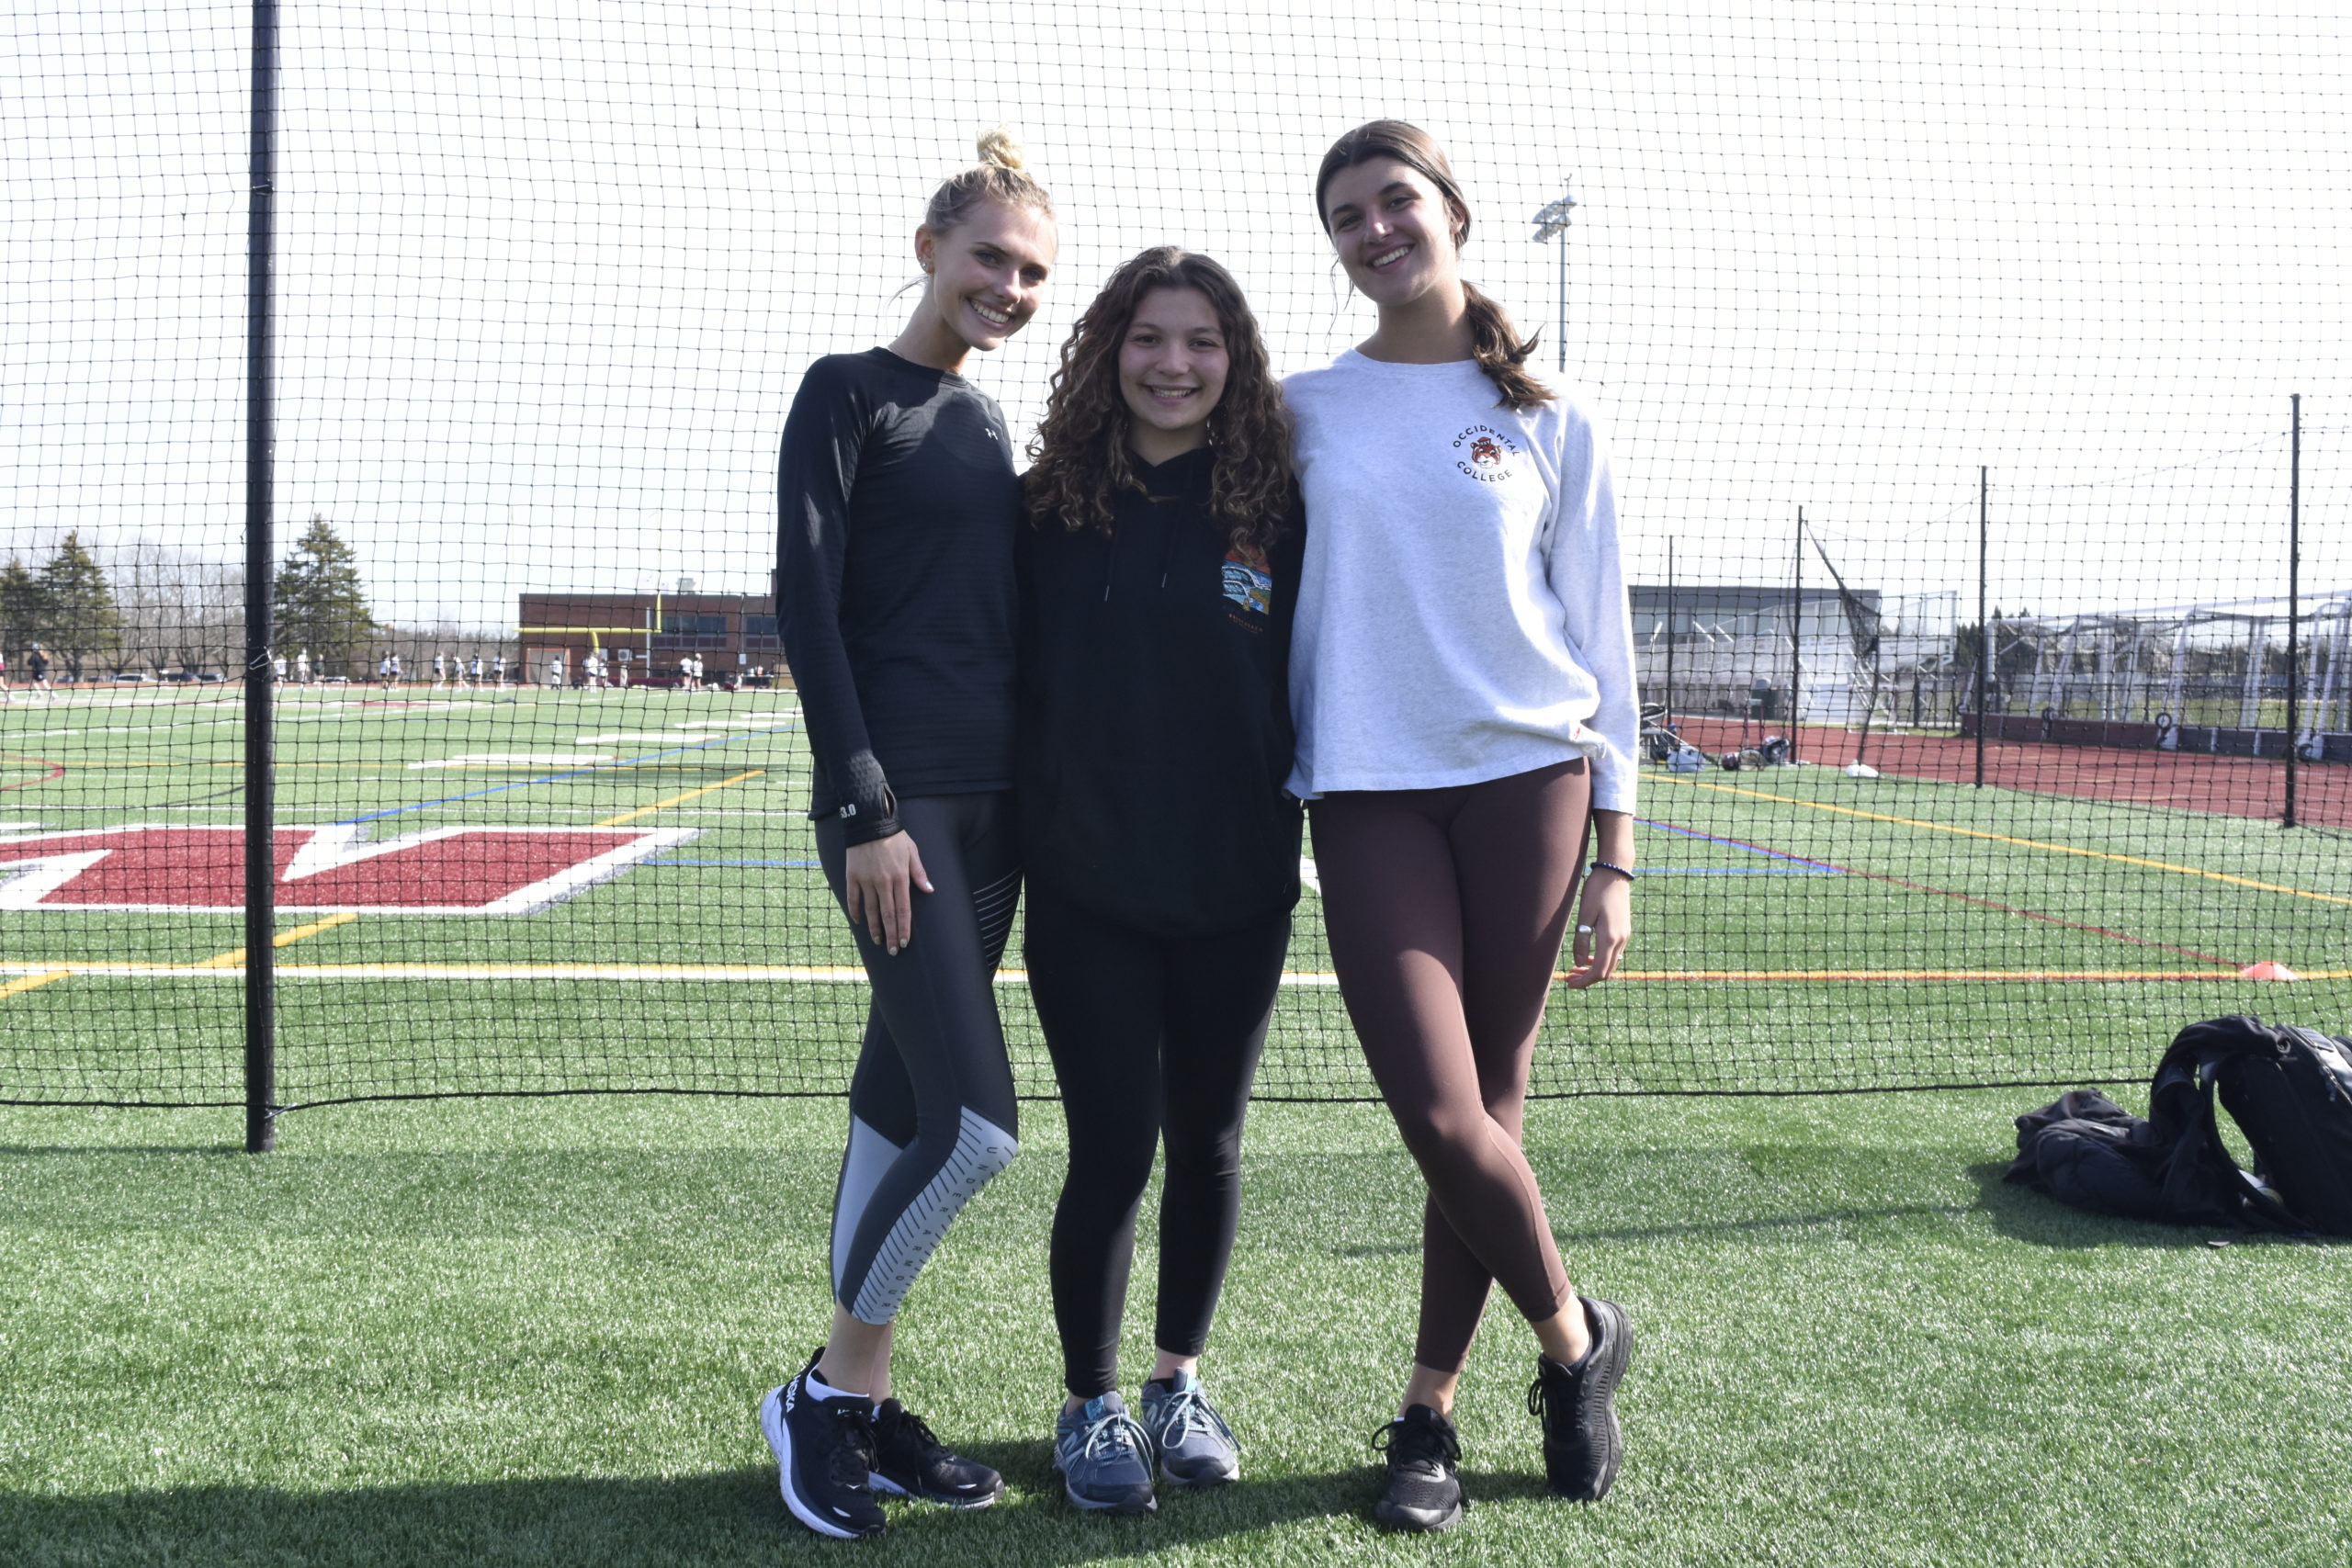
1679,717,2352,828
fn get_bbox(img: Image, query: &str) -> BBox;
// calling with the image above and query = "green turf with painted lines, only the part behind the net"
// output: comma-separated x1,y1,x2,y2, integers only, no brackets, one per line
0,689,2352,1102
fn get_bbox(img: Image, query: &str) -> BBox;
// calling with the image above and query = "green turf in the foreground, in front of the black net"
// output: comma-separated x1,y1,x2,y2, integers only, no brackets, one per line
0,1090,2352,1568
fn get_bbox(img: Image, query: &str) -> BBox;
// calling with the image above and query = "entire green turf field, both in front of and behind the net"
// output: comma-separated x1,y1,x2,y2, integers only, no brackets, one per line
0,689,2352,1563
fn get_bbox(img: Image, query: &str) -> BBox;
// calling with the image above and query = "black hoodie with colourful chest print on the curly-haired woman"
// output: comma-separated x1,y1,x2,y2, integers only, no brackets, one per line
1016,446,1306,936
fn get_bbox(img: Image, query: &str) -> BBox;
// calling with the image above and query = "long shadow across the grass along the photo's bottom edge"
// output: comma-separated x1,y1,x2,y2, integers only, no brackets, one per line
0,1443,1392,1568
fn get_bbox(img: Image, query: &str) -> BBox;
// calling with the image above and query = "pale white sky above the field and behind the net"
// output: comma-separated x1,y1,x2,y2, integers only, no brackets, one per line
0,0,2352,623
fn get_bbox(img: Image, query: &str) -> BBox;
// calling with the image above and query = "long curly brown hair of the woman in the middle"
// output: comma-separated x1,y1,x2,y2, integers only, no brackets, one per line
1023,244,1296,550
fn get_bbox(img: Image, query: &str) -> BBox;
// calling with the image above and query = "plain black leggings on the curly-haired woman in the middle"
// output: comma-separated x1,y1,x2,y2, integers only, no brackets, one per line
1023,886,1291,1399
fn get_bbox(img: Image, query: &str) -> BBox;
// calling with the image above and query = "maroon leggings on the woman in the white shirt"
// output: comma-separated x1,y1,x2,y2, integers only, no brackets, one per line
1310,760,1592,1373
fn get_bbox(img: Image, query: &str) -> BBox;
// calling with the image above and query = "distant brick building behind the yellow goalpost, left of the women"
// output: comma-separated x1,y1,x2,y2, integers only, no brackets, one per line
515,592,790,686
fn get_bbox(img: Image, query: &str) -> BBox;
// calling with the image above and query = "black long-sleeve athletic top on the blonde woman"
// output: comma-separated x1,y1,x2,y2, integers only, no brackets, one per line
776,348,1021,844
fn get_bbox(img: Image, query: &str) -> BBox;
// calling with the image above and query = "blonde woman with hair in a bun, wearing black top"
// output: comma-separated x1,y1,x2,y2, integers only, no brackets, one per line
760,131,1056,1538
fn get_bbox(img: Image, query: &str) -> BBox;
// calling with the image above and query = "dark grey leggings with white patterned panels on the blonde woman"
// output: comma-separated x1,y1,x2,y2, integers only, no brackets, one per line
816,792,1021,1324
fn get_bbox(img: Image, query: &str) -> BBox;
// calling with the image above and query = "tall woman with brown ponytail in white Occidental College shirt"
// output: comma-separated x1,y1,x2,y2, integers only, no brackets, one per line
1284,120,1637,1530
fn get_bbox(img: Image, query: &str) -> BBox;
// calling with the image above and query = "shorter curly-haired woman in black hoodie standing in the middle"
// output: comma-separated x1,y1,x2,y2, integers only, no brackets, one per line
1016,247,1306,1514
